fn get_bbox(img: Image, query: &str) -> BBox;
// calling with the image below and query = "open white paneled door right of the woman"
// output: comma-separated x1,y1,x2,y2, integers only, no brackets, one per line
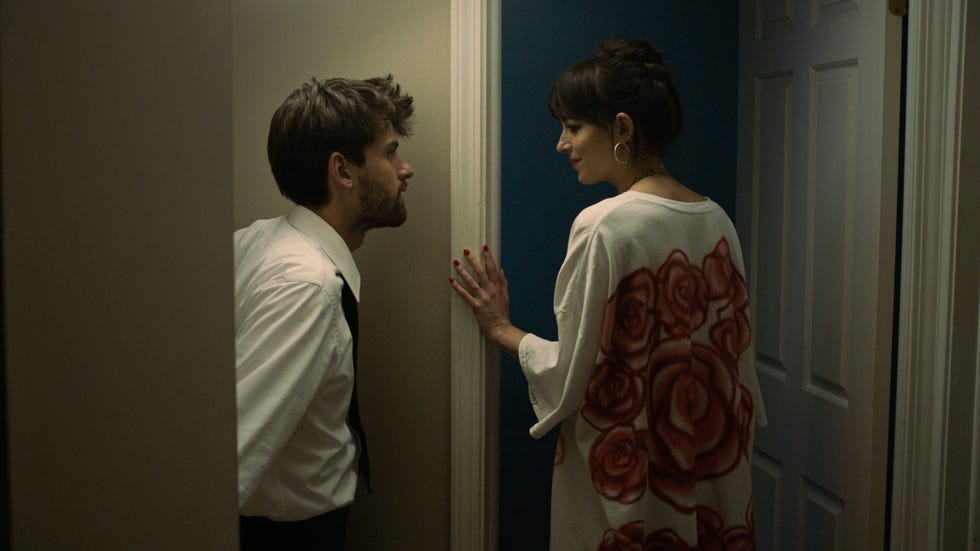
736,0,901,551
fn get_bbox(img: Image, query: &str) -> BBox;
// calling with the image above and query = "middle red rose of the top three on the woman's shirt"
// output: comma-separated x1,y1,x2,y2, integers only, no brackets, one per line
656,250,708,335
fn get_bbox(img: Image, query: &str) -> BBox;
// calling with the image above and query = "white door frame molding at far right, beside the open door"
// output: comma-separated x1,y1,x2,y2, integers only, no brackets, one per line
891,0,970,550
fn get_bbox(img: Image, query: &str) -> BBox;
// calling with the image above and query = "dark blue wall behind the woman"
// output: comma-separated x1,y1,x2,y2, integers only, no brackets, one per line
499,0,738,551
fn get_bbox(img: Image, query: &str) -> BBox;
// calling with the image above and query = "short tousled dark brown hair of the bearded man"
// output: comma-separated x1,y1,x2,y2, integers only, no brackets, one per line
267,75,414,207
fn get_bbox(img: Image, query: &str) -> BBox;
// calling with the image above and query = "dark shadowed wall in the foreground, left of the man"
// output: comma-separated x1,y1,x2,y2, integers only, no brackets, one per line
0,0,237,551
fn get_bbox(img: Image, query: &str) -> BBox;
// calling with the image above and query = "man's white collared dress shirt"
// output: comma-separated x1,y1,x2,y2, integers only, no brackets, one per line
234,206,361,521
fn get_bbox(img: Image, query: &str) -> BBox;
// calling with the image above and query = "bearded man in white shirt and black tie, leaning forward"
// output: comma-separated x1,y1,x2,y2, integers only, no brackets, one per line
234,75,414,550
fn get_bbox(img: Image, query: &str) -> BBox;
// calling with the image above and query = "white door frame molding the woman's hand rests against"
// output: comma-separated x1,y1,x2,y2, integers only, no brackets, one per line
446,0,500,551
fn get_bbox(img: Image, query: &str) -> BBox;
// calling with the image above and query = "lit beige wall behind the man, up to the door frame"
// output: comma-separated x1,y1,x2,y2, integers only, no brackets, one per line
232,0,450,550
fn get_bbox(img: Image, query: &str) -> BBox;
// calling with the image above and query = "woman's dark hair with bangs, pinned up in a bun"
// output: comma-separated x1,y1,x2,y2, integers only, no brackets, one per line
548,39,684,160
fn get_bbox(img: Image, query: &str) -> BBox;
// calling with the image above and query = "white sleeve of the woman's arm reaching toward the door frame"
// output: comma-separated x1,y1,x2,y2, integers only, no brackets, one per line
518,216,610,438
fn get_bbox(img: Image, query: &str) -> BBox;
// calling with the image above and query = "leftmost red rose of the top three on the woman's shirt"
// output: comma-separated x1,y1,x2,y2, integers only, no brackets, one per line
602,268,657,369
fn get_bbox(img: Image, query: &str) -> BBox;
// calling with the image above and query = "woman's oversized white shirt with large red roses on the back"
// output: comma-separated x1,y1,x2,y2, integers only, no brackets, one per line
544,192,765,549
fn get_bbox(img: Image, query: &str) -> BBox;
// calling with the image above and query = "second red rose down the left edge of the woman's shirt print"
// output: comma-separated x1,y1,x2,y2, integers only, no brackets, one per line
582,356,646,430
